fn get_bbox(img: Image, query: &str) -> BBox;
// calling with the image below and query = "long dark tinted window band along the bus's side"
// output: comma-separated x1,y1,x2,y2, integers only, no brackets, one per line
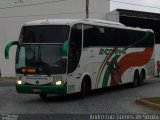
83,25,154,47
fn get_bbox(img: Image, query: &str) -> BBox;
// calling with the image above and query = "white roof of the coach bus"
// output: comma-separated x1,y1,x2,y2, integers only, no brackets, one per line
24,19,153,32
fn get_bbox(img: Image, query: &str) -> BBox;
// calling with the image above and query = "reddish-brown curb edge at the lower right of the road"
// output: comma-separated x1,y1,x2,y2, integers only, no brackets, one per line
135,98,160,110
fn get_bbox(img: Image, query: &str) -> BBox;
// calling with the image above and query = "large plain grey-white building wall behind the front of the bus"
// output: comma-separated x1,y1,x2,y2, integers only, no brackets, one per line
0,0,110,77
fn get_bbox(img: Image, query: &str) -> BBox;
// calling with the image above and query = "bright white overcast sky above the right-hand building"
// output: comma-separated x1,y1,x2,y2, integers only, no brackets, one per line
110,0,160,13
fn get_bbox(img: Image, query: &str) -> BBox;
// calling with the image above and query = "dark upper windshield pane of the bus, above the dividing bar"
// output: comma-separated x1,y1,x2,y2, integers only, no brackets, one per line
20,25,70,43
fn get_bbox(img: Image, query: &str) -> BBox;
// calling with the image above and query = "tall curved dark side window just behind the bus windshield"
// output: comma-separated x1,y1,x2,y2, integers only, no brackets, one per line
68,24,82,73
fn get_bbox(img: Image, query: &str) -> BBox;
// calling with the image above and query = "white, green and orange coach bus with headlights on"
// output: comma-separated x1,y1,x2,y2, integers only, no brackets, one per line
5,19,154,98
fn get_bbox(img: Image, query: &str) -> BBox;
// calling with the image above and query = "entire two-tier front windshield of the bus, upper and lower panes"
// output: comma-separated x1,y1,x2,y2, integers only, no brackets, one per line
16,25,70,75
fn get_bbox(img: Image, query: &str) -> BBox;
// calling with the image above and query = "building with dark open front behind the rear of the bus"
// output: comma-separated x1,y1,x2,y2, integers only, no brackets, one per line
107,9,160,75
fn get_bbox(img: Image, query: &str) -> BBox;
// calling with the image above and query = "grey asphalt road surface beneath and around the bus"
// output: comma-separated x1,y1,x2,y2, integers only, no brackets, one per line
0,78,160,119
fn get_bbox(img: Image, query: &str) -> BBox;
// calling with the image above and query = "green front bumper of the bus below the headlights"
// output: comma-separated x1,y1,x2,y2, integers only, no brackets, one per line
16,83,67,95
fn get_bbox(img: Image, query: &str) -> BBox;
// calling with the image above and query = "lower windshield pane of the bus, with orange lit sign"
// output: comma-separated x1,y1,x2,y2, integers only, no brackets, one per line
16,44,67,75
